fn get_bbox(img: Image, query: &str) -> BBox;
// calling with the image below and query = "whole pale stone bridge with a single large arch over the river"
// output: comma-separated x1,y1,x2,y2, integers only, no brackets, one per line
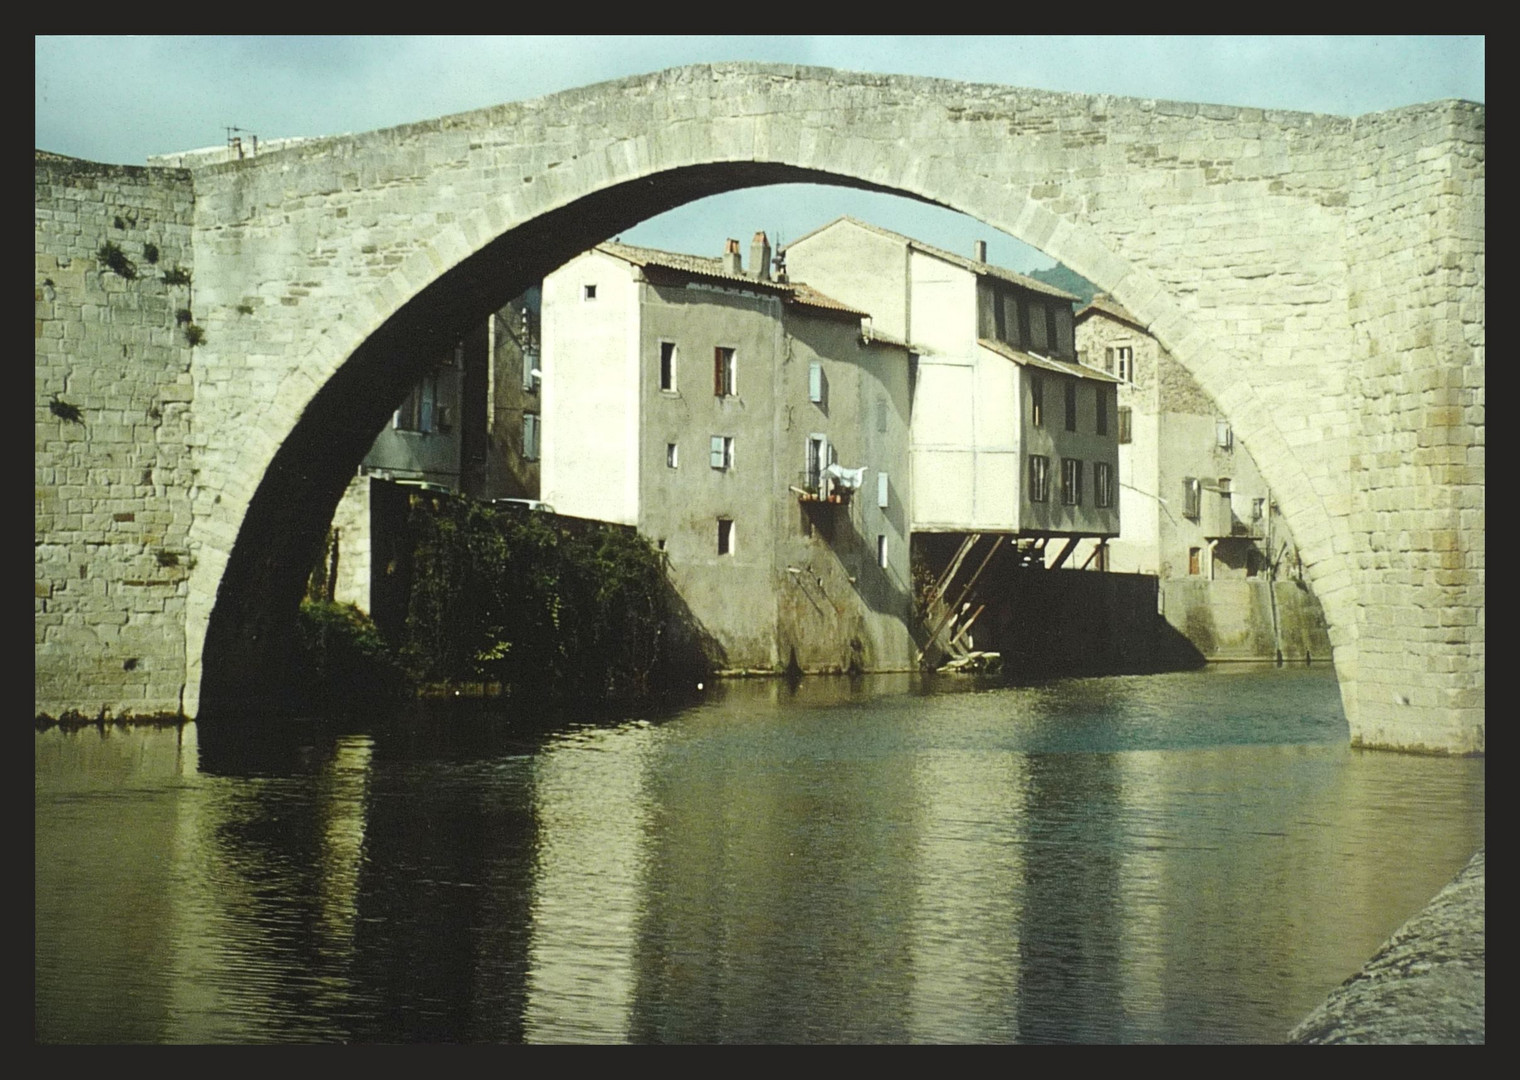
35,64,1485,752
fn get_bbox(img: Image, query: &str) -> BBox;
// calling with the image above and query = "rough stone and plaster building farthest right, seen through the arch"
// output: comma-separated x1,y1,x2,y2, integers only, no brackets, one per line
1075,293,1330,659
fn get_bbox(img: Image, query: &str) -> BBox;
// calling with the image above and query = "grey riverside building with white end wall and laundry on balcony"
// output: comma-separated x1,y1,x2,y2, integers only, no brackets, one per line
541,234,915,671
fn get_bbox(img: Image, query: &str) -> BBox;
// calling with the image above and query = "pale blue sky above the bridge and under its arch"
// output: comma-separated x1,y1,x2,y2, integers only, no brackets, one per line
33,35,1485,270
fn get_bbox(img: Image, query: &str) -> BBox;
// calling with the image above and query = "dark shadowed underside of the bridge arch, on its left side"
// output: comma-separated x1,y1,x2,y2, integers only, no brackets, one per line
198,161,944,723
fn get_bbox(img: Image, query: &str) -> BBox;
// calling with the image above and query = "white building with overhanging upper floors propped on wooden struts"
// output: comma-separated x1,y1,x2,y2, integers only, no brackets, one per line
786,217,1120,559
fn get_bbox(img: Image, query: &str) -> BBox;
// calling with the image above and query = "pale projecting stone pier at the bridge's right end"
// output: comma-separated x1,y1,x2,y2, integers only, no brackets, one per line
1342,102,1485,752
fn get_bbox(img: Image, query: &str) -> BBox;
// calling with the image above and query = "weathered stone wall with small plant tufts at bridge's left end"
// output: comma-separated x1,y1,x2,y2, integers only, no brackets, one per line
33,155,196,715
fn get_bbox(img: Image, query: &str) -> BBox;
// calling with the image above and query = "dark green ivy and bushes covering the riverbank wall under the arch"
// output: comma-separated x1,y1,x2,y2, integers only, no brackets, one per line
296,495,714,711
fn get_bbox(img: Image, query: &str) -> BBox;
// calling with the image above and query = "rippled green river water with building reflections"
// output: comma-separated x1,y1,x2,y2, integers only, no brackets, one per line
35,665,1485,1044
